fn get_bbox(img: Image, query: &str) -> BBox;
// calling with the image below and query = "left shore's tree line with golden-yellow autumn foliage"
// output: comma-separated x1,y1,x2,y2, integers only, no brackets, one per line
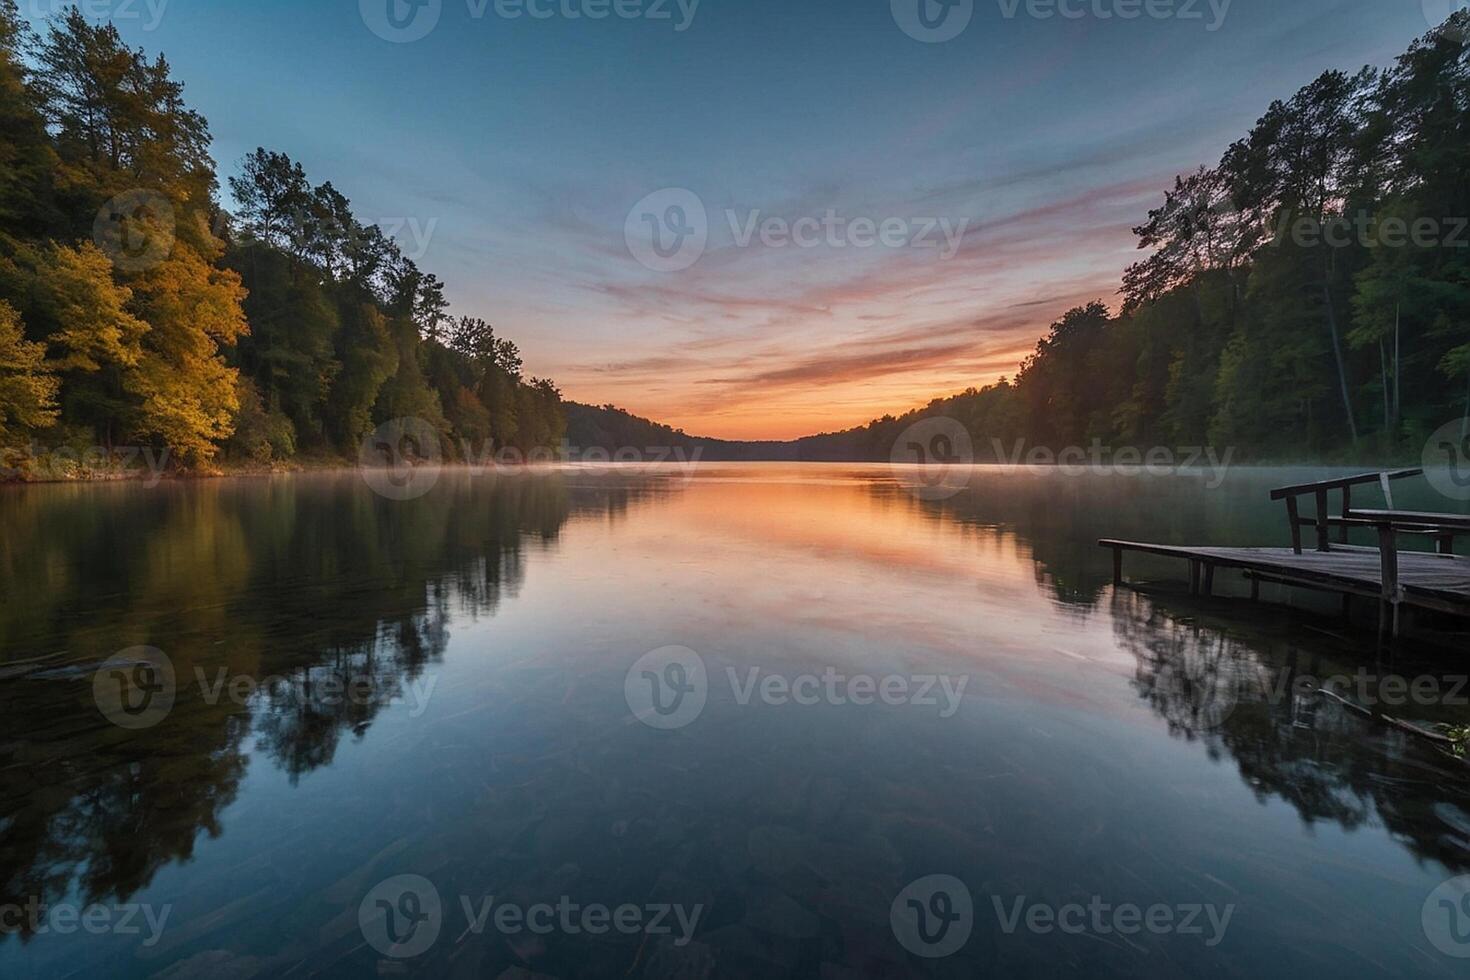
0,0,566,470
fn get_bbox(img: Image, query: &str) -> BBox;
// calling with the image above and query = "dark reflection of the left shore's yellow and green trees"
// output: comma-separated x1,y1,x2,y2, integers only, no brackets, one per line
0,470,673,934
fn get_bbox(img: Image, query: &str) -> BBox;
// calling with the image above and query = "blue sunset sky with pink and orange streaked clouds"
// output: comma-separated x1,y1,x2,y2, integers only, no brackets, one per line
19,0,1463,439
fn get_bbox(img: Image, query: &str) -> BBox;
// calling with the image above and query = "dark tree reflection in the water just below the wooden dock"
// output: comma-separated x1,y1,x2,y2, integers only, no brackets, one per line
1111,591,1470,870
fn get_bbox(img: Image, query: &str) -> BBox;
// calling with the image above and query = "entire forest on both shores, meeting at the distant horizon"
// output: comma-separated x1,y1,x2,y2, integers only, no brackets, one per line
0,0,1470,475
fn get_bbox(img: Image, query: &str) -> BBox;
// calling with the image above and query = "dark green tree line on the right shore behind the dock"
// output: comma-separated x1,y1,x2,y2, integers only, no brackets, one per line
801,12,1470,461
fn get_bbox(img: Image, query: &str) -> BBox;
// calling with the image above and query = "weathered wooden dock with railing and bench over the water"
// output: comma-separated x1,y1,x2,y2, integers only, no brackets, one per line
1098,470,1470,636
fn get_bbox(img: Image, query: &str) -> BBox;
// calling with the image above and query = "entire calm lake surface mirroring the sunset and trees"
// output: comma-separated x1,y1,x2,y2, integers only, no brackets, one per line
0,464,1470,979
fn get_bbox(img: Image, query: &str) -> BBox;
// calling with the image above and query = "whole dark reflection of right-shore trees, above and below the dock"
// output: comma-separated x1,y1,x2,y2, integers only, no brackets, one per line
875,467,1470,870
